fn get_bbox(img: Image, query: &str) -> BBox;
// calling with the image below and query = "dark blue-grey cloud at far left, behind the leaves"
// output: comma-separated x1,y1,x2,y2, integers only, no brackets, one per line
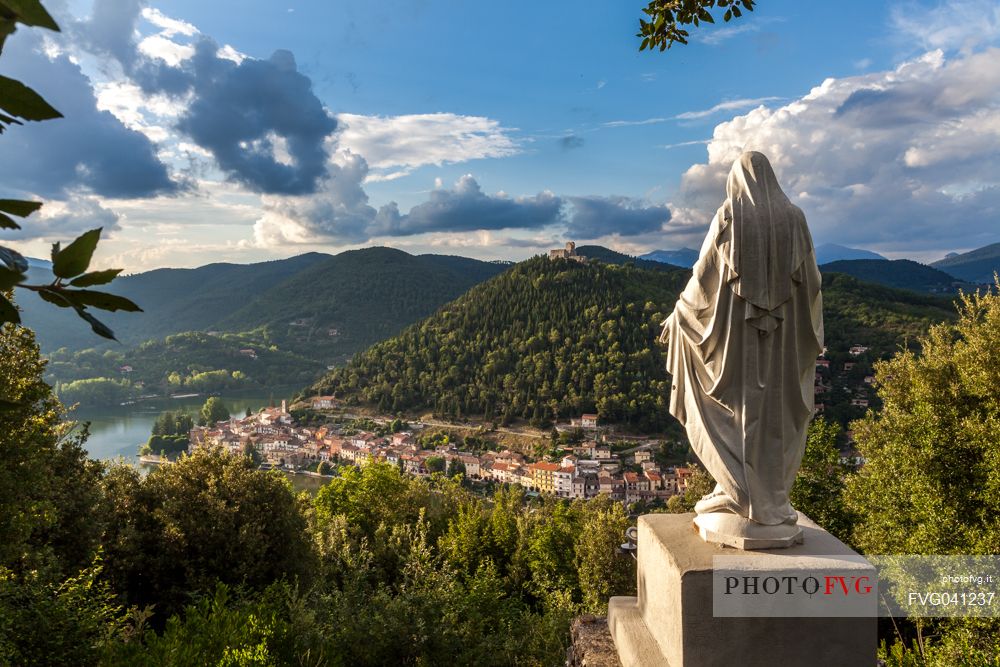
0,31,178,198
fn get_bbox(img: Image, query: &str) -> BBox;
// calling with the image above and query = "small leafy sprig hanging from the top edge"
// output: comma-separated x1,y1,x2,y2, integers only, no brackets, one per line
636,0,755,51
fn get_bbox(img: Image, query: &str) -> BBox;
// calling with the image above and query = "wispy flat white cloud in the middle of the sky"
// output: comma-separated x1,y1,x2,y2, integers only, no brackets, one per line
336,113,520,177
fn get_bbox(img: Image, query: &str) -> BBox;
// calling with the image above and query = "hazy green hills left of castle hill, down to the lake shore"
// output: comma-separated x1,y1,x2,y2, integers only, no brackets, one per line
38,248,507,404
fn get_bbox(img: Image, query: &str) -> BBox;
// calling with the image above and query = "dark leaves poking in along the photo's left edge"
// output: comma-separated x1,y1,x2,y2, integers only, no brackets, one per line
0,0,142,344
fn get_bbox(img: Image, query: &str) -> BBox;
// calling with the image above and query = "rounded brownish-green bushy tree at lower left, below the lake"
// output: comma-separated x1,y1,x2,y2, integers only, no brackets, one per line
103,449,314,624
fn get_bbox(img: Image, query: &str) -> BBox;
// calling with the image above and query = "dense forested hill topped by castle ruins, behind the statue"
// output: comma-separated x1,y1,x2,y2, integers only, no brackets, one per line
309,257,954,428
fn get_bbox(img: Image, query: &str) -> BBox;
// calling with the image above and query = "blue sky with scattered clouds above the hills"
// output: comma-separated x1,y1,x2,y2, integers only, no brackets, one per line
0,0,1000,270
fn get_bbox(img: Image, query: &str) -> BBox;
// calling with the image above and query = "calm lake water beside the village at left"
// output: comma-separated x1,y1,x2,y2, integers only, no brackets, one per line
75,387,326,493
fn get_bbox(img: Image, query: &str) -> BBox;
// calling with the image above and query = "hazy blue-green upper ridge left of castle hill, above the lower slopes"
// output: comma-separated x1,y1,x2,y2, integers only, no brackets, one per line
19,248,506,362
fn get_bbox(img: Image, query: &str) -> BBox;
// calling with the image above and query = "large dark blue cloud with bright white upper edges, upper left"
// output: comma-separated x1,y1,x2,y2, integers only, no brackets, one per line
74,0,337,195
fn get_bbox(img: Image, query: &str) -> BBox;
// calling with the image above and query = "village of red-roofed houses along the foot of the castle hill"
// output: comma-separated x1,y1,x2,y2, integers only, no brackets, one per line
190,402,693,503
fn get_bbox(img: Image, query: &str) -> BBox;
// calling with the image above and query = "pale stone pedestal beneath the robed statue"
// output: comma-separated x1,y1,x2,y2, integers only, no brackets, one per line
608,514,877,667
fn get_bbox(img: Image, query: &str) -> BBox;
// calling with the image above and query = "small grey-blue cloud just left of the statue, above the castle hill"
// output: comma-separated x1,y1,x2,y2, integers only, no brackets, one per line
566,197,670,239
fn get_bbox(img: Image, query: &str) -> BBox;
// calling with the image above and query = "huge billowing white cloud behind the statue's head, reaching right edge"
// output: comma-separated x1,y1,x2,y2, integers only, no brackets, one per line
670,49,1000,251
